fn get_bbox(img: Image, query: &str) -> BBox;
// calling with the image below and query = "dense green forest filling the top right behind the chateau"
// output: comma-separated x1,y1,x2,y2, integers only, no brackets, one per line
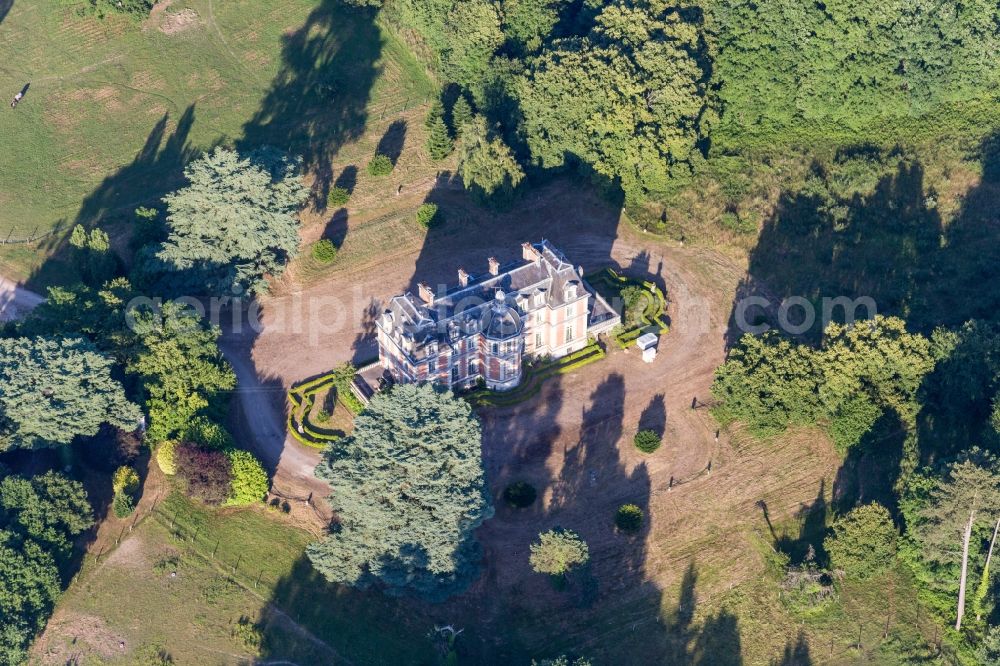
351,0,1000,204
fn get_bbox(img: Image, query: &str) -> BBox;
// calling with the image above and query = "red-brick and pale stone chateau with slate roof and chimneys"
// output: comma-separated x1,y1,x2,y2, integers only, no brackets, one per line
376,240,621,390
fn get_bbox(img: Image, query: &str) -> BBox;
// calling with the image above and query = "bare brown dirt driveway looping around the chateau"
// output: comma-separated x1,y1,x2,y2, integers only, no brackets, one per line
238,182,744,504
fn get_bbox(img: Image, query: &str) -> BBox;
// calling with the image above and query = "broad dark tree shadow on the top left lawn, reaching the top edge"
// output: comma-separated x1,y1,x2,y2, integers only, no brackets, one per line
238,0,383,205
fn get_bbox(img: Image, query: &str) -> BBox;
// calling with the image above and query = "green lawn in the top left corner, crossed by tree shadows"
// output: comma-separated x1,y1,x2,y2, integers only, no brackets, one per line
0,0,434,277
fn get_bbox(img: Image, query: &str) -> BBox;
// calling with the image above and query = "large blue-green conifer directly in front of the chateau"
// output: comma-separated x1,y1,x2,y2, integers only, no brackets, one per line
307,384,493,600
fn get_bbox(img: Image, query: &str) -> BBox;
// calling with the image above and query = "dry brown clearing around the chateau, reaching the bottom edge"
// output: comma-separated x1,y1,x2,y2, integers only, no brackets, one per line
211,179,937,663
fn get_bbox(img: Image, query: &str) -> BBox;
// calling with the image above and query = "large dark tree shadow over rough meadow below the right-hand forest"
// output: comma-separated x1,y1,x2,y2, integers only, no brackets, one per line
729,135,1000,344
